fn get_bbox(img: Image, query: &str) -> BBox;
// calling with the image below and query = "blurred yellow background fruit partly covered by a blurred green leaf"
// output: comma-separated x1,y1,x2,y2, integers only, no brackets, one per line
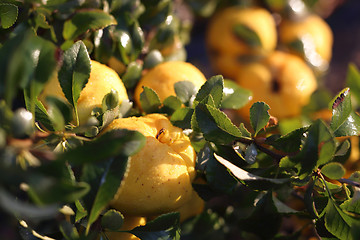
206,7,277,79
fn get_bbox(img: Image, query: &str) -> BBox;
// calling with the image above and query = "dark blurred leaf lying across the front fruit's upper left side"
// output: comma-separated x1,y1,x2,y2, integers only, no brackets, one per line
58,129,145,165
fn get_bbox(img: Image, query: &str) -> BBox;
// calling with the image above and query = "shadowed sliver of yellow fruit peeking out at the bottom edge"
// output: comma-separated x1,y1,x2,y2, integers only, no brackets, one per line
105,216,146,240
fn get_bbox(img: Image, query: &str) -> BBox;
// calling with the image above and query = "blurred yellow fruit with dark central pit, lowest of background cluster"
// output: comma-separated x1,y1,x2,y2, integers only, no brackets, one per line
236,51,317,119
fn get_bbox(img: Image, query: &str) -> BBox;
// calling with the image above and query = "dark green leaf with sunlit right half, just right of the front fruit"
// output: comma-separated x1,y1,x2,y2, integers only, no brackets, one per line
195,103,242,144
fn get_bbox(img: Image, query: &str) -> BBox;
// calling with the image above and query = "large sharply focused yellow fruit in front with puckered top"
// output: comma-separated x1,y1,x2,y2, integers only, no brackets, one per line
104,114,196,216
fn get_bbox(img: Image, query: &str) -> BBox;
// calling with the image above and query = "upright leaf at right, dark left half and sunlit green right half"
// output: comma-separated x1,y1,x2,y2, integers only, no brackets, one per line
280,120,336,179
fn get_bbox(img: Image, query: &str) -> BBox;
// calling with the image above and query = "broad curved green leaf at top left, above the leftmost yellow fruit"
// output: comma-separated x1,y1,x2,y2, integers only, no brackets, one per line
63,9,117,40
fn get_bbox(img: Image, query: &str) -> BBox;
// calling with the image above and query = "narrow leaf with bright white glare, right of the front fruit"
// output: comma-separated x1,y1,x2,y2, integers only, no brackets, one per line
214,154,289,184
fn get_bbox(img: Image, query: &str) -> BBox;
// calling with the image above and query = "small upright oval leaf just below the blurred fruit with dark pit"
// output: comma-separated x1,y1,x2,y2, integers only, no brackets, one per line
250,102,270,136
